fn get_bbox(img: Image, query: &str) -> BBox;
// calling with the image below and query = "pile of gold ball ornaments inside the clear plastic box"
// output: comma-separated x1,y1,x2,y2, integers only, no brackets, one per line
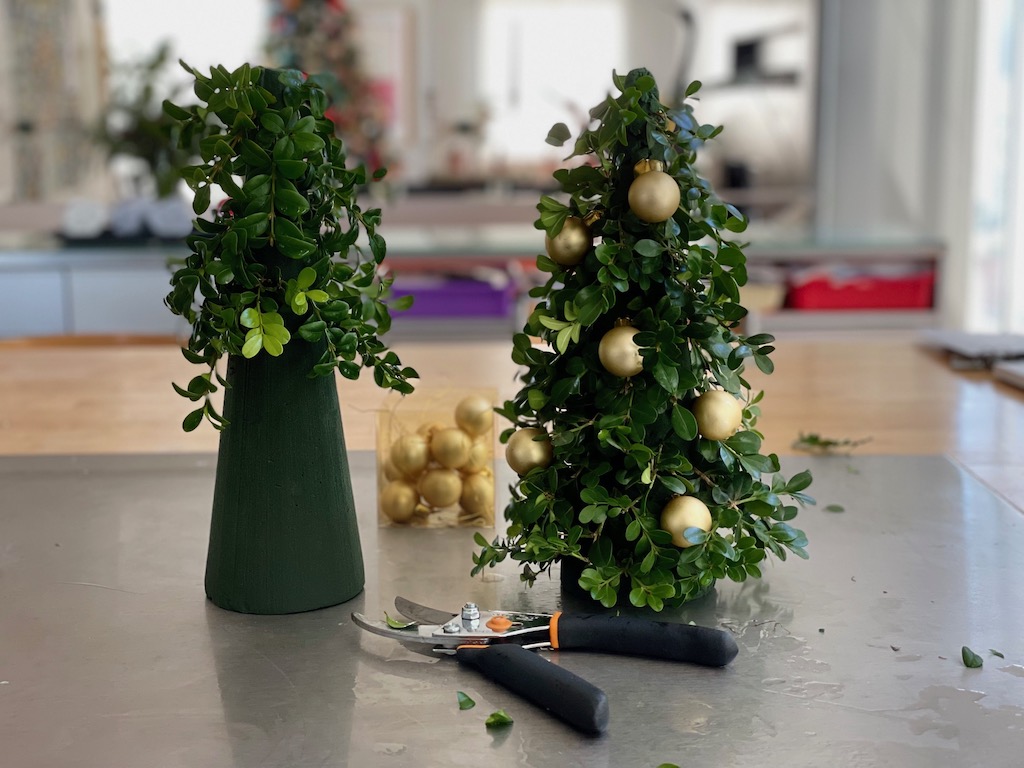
380,395,495,525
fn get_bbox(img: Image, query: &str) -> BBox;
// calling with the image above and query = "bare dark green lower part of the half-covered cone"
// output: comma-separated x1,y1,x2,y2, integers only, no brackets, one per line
206,339,364,613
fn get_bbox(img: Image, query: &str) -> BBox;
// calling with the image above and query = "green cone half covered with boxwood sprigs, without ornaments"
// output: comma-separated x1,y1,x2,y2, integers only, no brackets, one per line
164,63,416,613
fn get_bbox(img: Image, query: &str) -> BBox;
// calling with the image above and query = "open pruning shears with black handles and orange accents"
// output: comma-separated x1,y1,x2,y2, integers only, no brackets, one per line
352,597,738,735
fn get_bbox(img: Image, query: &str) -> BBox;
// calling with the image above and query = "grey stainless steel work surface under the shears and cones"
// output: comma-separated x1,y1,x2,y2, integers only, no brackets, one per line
0,454,1024,768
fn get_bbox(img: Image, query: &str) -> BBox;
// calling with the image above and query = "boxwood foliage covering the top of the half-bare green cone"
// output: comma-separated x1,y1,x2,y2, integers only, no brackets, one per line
164,62,416,430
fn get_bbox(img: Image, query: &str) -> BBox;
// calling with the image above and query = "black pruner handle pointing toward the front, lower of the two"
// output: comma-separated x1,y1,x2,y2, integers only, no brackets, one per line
455,643,608,736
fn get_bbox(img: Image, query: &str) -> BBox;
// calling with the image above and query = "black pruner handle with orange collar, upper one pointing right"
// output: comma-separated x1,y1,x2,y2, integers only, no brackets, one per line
551,613,739,667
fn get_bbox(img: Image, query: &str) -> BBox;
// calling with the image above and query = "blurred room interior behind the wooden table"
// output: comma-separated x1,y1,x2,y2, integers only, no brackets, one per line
0,0,1024,339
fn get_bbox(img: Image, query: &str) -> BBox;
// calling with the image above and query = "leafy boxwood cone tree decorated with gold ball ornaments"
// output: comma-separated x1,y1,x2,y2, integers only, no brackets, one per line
473,69,813,610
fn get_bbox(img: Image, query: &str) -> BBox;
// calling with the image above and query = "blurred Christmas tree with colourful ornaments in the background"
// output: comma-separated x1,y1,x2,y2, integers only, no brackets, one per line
267,0,393,171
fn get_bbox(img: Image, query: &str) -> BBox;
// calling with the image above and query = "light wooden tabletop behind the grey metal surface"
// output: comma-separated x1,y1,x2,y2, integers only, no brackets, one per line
0,333,1024,509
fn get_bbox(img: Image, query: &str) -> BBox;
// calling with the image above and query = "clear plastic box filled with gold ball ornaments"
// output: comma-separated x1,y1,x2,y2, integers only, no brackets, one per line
377,389,497,527
